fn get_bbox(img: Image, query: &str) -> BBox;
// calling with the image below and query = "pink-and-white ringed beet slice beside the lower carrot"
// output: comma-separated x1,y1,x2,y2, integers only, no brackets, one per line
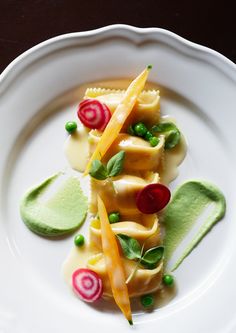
72,268,102,302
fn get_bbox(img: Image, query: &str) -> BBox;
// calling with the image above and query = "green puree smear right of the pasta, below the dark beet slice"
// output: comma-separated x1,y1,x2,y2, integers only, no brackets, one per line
163,180,226,271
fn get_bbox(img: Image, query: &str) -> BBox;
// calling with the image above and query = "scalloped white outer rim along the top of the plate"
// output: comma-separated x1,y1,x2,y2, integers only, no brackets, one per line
0,24,236,93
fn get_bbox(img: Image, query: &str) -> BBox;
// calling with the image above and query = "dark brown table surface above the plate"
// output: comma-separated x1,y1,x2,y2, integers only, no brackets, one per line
0,0,236,72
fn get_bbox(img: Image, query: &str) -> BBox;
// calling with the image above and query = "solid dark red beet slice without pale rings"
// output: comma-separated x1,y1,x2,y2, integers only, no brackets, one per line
136,184,171,214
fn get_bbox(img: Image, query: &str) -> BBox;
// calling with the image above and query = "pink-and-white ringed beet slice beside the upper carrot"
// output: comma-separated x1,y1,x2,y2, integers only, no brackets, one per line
77,99,111,131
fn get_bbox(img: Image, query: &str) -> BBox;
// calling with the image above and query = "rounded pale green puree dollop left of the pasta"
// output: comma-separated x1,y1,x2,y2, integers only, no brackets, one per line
20,173,88,237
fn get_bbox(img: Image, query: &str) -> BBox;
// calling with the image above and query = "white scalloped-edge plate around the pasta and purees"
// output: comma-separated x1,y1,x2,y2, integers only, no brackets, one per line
0,25,236,333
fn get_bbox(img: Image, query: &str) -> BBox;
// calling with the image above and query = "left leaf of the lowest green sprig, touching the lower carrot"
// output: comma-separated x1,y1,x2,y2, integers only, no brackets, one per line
116,234,141,260
